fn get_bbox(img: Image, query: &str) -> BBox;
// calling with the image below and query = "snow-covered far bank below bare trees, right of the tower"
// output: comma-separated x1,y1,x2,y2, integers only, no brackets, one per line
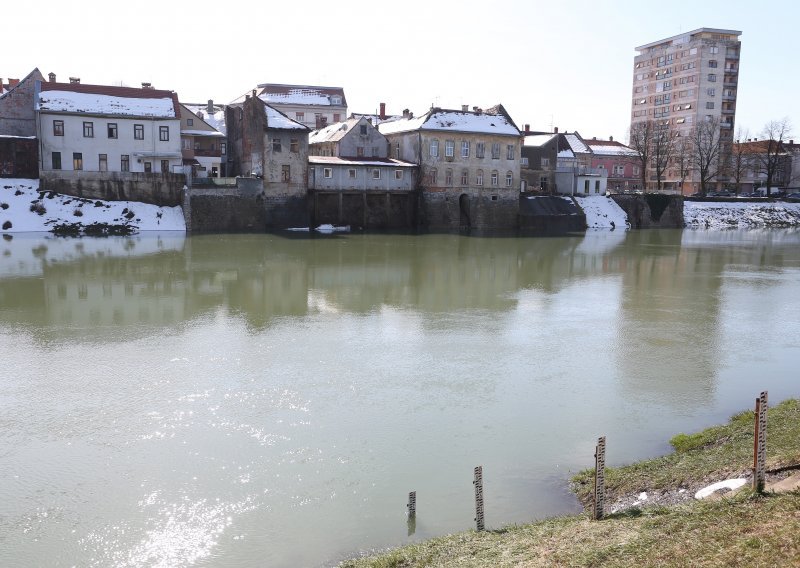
683,201,800,229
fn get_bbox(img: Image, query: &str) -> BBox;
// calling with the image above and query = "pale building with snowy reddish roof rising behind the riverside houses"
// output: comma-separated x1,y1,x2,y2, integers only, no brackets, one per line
247,83,347,130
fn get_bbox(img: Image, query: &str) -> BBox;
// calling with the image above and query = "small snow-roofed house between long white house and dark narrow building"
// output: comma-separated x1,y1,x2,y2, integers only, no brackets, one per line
181,101,227,179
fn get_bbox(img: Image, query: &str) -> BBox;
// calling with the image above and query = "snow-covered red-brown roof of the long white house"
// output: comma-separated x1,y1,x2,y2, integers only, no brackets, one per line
36,82,181,118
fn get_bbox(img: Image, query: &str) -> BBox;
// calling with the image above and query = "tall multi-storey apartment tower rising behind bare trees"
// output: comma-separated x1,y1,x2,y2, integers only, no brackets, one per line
631,28,742,194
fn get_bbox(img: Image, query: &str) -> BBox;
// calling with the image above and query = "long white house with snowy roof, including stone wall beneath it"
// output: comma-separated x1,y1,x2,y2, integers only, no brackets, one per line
35,79,185,205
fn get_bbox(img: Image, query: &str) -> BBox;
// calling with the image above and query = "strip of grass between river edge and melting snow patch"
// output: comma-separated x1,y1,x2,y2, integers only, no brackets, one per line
572,399,800,504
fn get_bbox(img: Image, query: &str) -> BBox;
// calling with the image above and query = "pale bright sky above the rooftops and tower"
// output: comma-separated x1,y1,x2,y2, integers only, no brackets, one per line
6,0,800,141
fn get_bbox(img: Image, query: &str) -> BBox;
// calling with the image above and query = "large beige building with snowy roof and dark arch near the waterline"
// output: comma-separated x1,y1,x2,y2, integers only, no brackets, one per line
378,105,522,230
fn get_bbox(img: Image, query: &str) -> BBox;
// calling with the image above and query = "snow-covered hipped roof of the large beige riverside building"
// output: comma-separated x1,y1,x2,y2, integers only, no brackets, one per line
378,106,520,136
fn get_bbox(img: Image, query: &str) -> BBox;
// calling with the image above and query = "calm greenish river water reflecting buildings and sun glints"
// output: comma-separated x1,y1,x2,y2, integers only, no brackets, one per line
0,230,800,567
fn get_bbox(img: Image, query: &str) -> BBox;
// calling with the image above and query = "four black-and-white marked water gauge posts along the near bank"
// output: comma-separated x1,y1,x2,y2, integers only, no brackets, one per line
406,391,767,536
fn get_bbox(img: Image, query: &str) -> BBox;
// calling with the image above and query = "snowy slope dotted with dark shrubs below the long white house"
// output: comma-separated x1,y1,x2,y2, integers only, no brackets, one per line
0,182,186,233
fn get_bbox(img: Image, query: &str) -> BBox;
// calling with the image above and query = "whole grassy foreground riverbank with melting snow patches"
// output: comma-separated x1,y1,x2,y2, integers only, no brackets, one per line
341,400,800,568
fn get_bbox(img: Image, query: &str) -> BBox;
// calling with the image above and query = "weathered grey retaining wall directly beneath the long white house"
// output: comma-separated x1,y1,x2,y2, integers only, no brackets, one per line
39,171,185,206
